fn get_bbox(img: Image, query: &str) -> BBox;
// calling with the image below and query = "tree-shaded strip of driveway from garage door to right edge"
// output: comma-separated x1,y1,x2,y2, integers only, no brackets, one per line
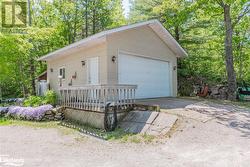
136,98,250,138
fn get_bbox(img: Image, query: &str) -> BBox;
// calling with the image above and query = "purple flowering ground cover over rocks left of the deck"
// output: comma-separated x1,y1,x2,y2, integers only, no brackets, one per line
7,105,53,120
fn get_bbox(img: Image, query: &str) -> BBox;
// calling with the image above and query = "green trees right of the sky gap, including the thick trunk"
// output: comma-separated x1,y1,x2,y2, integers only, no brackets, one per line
129,0,250,98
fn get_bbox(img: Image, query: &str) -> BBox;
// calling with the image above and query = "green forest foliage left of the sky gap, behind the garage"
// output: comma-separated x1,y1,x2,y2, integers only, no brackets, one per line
0,0,126,97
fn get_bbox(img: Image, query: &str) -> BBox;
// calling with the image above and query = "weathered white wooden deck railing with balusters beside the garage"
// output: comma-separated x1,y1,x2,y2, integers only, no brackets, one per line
60,85,137,111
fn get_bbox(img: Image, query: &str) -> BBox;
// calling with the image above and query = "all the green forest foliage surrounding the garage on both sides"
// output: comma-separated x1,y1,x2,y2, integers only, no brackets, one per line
0,0,250,97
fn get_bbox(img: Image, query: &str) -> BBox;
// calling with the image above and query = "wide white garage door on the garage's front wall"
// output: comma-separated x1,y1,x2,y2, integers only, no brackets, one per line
118,54,171,98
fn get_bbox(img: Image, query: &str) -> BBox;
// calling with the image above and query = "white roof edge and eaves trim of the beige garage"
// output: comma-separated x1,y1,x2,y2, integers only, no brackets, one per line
38,20,187,61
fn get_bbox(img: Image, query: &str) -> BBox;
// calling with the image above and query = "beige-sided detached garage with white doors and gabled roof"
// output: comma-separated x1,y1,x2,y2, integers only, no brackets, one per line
39,20,187,99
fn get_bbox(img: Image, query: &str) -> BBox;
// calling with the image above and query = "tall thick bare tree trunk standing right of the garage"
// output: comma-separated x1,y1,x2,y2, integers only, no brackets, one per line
223,4,237,100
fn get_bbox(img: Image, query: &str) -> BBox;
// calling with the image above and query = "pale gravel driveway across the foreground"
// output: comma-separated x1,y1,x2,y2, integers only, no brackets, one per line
0,98,250,167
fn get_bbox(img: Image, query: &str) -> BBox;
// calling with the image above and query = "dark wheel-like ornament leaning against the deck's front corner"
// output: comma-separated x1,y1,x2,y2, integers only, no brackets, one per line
104,103,117,132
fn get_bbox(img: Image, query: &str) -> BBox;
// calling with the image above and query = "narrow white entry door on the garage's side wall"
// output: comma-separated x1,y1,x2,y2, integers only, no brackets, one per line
87,57,99,85
